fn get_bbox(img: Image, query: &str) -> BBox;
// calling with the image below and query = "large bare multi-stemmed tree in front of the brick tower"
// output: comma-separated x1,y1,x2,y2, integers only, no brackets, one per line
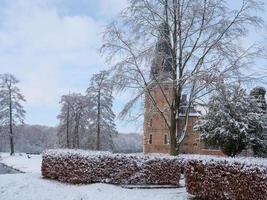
102,0,263,155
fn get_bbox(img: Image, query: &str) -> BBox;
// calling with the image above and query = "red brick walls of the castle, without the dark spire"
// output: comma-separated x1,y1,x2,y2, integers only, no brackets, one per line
144,84,223,155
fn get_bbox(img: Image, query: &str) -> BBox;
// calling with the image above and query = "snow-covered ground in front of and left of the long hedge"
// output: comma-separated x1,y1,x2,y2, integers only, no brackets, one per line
0,153,194,200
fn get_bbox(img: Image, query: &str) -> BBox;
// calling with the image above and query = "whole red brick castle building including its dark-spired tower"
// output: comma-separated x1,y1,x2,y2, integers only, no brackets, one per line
144,24,222,155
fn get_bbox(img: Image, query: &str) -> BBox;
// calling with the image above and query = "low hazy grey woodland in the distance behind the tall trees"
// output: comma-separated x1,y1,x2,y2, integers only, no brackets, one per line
0,124,143,154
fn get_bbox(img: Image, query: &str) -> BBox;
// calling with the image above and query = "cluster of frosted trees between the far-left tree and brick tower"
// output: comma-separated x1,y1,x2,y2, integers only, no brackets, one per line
58,71,117,150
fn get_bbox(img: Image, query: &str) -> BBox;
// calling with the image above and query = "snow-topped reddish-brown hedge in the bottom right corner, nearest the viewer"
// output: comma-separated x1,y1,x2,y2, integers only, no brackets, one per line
184,156,267,200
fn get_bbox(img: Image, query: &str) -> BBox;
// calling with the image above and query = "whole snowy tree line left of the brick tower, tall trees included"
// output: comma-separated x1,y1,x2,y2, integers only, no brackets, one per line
0,71,143,155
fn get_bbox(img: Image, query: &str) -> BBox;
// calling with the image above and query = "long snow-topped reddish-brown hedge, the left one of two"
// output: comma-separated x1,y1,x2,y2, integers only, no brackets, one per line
42,150,181,185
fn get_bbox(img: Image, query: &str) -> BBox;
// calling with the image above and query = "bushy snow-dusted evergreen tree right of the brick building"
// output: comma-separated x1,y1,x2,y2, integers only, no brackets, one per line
195,85,264,156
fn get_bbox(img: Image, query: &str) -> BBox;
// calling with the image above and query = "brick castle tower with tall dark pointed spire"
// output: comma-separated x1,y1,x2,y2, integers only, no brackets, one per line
144,23,172,153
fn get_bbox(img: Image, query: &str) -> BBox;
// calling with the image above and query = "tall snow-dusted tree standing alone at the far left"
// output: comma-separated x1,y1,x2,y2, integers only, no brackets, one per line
0,74,25,155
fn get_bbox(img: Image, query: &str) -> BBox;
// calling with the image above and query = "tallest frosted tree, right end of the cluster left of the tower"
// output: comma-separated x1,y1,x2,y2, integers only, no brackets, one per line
87,71,116,150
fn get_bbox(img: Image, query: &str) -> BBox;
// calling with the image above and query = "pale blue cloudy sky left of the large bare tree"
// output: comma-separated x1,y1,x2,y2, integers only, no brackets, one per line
0,0,267,132
